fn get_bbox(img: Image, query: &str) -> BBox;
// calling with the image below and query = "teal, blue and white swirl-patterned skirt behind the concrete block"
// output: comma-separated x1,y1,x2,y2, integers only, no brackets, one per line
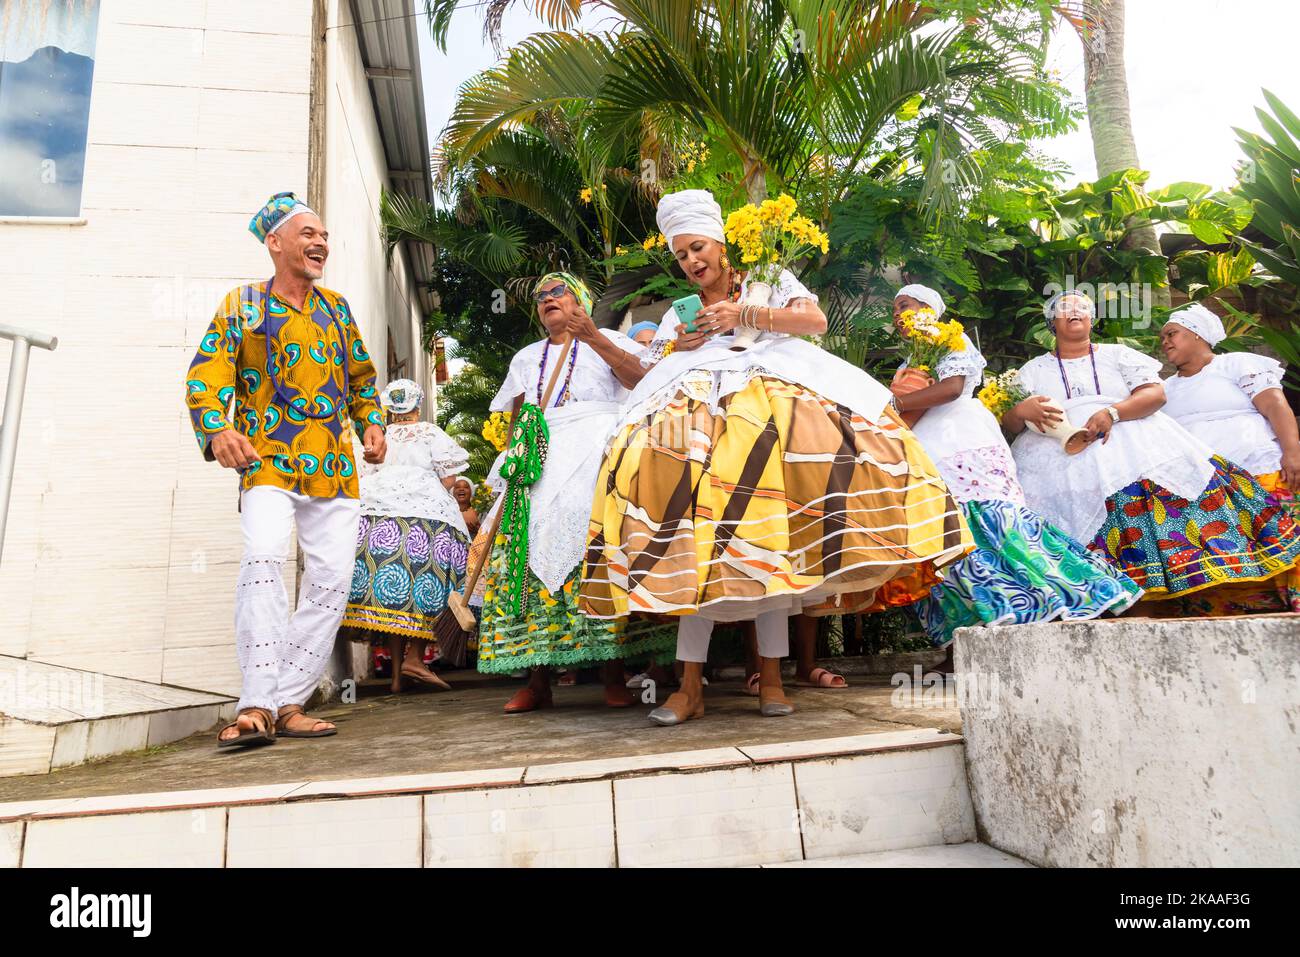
917,502,1141,646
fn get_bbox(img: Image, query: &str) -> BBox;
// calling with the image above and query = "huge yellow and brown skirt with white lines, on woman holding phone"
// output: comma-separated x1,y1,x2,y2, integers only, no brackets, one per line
580,373,972,622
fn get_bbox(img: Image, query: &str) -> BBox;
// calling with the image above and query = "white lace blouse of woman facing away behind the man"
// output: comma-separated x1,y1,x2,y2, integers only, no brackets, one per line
358,423,469,538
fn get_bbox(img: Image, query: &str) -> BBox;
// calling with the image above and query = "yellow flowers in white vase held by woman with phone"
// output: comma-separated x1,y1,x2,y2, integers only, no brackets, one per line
723,192,829,348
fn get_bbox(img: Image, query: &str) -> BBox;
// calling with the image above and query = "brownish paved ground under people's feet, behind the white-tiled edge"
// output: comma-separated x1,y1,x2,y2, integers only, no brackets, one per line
0,672,961,801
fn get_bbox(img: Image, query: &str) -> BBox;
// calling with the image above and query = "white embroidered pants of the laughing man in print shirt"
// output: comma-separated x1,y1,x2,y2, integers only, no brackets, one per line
235,485,361,714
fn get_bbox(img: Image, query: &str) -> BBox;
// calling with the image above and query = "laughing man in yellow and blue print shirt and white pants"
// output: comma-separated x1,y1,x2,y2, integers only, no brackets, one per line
186,192,386,746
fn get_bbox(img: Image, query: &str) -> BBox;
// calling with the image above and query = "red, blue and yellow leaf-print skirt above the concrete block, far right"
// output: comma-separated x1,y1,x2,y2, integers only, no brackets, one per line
1088,455,1300,601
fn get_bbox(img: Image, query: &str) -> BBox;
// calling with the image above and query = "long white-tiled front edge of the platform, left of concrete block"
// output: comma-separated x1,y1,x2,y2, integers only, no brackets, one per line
0,729,975,867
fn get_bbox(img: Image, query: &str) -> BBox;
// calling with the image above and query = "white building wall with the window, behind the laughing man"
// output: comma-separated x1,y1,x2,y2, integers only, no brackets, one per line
0,0,315,692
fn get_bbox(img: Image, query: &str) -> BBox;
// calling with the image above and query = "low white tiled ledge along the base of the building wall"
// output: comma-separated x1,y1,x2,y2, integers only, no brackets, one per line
0,655,235,778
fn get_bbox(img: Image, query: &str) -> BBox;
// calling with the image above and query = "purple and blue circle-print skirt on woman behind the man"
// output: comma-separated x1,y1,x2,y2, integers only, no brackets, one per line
342,515,469,641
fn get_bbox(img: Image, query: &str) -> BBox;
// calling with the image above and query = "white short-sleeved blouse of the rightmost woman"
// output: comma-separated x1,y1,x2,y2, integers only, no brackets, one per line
1165,352,1282,475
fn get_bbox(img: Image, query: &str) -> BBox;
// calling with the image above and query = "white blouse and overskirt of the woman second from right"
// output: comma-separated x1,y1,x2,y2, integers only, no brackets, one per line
1011,343,1214,544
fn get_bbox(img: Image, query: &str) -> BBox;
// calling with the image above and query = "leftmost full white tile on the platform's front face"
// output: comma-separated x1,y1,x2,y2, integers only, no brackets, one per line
22,807,226,867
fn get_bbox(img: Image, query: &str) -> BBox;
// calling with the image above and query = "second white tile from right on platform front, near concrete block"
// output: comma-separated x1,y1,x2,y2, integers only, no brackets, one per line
614,765,802,867
